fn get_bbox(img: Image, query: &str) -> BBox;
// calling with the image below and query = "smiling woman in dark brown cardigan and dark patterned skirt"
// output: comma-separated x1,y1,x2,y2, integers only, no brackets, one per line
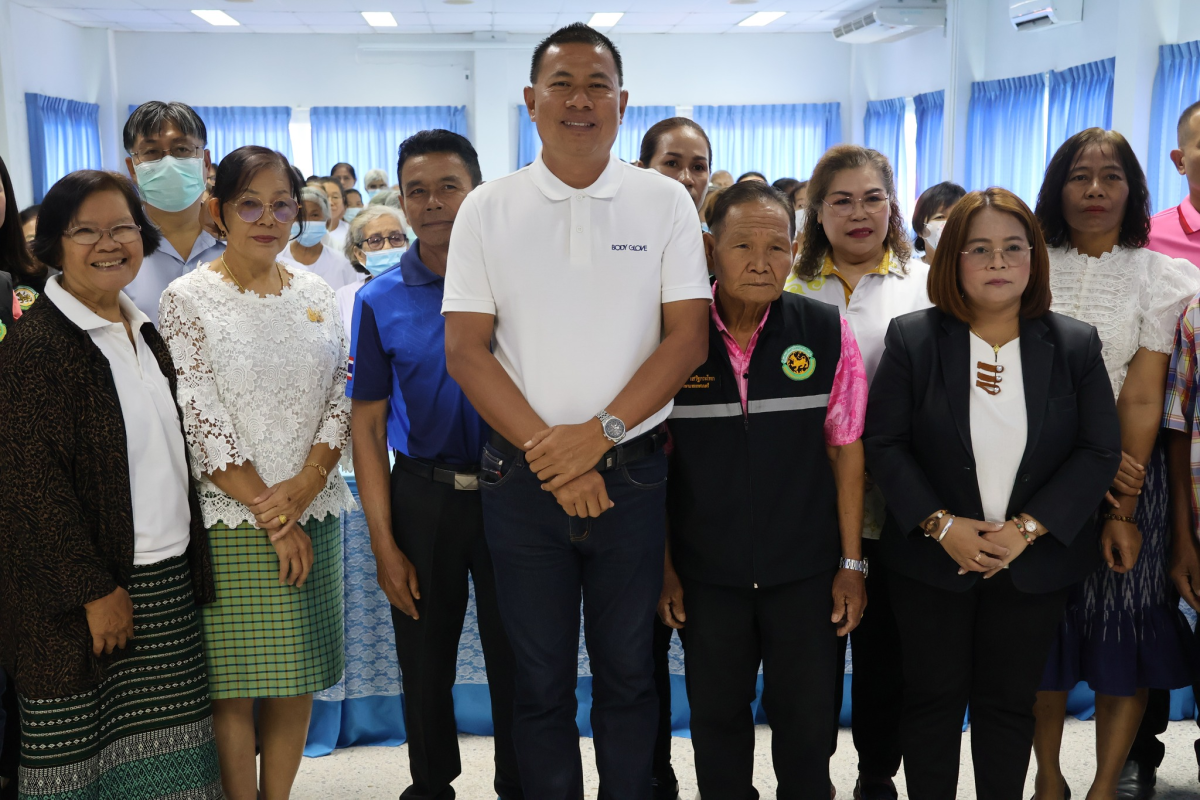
0,170,221,800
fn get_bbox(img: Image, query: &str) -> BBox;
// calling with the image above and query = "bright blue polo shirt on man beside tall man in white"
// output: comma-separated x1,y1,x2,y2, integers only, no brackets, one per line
346,242,487,465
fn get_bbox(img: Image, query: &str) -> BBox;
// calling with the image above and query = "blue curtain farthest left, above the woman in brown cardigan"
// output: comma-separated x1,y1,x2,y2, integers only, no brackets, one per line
25,92,102,203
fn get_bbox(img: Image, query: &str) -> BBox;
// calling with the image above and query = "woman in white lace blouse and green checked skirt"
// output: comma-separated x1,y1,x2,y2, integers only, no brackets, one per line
160,146,354,800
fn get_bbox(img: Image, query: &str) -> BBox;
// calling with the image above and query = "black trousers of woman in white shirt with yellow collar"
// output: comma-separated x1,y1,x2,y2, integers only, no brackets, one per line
850,539,904,780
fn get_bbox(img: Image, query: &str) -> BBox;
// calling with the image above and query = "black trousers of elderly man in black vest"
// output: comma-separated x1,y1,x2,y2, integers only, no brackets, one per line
683,572,840,800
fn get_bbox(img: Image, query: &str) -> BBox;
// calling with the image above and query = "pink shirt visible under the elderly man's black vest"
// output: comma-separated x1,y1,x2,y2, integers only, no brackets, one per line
709,283,866,447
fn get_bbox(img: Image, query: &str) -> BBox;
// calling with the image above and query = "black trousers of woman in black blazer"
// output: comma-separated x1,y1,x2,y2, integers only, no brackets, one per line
892,570,1067,800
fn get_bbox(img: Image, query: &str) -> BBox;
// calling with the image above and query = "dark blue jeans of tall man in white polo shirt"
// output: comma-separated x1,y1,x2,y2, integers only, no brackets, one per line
480,446,667,800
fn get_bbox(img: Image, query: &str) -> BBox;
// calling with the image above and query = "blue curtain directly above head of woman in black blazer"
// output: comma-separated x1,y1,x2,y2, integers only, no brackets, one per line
967,72,1046,206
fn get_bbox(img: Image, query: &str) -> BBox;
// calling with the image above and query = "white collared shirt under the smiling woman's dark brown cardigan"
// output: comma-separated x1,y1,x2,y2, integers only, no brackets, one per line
46,276,192,565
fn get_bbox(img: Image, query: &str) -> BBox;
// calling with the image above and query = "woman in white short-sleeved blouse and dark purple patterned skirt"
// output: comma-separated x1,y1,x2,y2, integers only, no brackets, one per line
1034,128,1200,800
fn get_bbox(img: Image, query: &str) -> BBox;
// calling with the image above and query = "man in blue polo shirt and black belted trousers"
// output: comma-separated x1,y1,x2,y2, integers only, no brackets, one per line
346,130,524,800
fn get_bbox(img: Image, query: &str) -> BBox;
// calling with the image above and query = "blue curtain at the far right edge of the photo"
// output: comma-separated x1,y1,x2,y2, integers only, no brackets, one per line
1146,41,1200,212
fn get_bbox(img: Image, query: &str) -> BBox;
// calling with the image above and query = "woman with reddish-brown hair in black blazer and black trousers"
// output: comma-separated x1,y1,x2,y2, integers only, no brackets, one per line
863,188,1121,800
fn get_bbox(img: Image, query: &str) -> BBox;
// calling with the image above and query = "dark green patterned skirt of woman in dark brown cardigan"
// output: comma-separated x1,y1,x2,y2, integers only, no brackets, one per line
18,555,224,800
